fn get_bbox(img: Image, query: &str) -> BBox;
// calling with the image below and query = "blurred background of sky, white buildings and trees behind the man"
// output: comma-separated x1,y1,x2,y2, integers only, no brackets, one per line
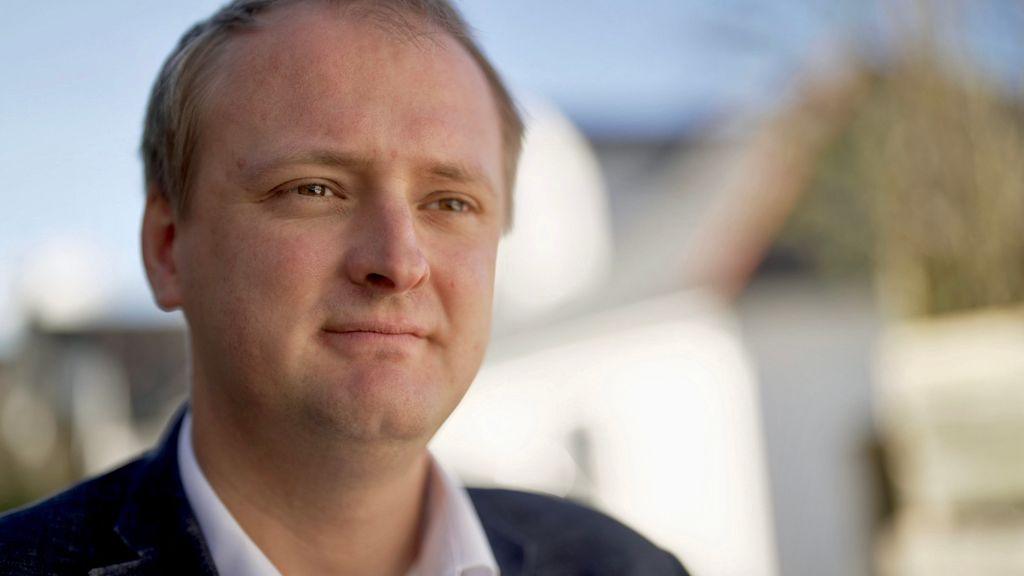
0,0,1024,576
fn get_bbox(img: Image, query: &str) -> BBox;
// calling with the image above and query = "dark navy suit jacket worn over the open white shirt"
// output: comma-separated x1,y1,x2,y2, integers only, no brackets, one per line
0,415,686,576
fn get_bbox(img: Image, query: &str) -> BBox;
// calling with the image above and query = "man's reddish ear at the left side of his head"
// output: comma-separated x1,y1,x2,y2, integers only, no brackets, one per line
142,189,181,311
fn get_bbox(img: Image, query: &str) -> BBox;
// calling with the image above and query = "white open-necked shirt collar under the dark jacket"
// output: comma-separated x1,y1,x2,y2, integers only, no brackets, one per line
178,412,499,576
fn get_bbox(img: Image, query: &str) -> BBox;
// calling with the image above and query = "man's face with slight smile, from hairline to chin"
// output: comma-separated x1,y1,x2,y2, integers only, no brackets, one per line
165,4,505,440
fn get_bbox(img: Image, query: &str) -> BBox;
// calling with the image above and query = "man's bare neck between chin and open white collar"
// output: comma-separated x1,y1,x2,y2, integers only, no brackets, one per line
193,393,428,575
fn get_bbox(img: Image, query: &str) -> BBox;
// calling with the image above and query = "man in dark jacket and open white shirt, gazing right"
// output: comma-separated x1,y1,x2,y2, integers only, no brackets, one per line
0,0,684,576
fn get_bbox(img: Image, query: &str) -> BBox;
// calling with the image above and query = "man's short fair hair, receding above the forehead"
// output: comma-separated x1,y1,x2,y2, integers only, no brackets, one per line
141,0,523,228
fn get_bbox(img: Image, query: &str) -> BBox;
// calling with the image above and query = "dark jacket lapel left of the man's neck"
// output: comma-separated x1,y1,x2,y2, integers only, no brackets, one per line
89,407,217,576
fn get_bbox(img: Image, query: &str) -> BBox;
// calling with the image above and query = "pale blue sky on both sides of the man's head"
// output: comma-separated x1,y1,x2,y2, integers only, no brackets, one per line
0,0,1024,346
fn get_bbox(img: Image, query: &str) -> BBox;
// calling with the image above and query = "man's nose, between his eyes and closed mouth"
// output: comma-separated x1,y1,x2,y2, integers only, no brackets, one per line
345,201,430,293
